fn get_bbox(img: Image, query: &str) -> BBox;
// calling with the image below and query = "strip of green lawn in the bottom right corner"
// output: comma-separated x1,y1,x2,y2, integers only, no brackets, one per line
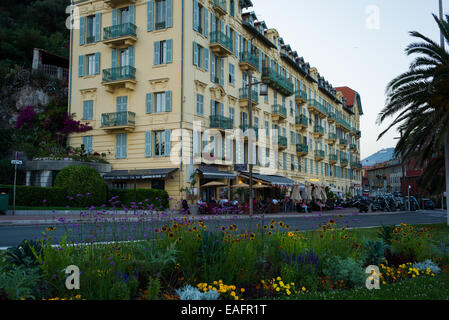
289,273,449,300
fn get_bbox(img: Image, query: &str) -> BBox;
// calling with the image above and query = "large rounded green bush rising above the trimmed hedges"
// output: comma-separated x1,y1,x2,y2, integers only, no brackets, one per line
55,165,107,207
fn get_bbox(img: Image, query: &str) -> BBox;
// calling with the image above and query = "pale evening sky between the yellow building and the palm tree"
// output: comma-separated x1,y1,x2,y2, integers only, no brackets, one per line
250,0,442,159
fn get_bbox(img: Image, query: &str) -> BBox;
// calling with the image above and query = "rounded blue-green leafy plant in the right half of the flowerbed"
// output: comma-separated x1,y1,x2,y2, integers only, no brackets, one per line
323,256,366,288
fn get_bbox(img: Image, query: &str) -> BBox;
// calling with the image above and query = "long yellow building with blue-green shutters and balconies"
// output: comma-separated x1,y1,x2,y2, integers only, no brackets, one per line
69,0,363,205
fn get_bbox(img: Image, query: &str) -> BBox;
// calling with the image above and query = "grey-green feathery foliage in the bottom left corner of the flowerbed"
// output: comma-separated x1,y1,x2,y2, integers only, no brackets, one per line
0,266,39,300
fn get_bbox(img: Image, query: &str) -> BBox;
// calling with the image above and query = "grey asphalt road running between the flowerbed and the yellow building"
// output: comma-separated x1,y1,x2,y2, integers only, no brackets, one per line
0,211,447,248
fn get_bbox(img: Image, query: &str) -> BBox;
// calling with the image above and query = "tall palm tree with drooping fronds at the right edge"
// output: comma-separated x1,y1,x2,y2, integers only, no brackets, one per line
378,15,449,223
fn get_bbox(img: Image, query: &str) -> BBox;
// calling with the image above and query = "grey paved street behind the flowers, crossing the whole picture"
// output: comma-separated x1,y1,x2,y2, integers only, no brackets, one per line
0,210,446,249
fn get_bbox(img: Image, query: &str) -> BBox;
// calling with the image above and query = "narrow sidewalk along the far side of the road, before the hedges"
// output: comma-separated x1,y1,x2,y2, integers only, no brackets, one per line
0,208,408,226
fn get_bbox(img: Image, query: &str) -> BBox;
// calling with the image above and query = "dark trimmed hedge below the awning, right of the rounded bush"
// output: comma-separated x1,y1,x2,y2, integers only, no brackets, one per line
108,189,168,210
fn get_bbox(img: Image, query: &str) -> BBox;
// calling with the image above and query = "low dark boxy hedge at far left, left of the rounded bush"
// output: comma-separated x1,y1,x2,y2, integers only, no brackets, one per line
0,185,68,207
